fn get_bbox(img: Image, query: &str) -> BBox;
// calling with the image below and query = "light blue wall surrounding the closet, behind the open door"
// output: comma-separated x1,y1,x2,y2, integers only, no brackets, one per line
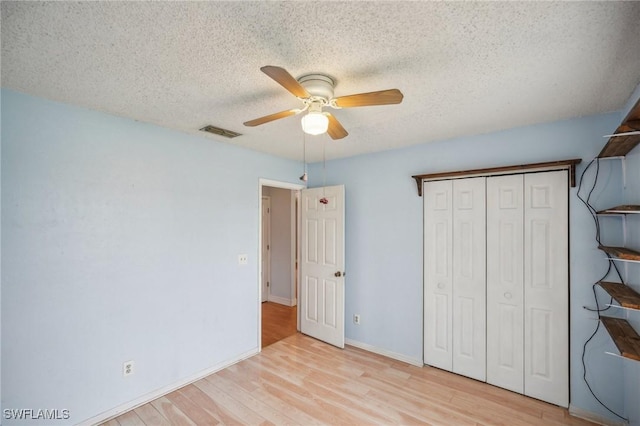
309,113,623,422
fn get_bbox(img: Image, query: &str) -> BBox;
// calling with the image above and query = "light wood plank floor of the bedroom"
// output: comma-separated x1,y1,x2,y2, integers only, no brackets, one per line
104,333,591,426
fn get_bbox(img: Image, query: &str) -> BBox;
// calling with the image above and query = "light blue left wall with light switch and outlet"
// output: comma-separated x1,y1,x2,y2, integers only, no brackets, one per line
1,91,300,424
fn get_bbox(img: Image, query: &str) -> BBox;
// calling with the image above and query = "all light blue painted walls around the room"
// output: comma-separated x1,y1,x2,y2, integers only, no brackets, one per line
1,85,640,424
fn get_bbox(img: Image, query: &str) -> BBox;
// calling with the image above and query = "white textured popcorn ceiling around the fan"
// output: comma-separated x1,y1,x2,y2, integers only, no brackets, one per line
1,1,640,161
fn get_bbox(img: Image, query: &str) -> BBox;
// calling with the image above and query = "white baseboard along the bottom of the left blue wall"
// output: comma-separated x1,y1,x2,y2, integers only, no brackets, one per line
78,348,259,426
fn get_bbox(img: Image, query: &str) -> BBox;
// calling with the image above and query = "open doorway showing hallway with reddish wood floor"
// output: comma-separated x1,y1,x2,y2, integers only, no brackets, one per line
258,179,304,348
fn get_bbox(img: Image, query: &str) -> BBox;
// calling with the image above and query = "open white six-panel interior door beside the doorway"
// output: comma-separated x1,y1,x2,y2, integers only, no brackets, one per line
298,185,345,348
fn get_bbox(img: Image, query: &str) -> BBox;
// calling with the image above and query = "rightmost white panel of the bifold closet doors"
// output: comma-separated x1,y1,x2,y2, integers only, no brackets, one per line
524,171,569,407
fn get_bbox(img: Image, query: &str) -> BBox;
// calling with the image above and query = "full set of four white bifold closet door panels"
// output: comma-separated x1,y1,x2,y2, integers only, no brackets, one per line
423,170,569,407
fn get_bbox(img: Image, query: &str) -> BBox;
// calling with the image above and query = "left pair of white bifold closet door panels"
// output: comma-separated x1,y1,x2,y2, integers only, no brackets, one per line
423,177,486,381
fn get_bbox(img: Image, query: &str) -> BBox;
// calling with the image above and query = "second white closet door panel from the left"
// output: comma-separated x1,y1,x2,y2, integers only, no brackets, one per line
453,177,487,381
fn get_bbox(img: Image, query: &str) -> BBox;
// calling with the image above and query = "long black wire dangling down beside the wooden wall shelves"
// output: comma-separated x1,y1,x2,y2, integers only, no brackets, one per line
576,157,629,422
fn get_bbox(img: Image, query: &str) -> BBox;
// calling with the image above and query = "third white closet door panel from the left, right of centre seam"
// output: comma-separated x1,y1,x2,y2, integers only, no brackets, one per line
487,175,524,393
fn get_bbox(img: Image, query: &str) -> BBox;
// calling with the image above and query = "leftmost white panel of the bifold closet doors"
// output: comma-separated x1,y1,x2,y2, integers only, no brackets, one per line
422,181,453,371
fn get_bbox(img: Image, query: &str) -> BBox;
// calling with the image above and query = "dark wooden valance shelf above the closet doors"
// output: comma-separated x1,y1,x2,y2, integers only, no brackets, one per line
411,158,582,197
